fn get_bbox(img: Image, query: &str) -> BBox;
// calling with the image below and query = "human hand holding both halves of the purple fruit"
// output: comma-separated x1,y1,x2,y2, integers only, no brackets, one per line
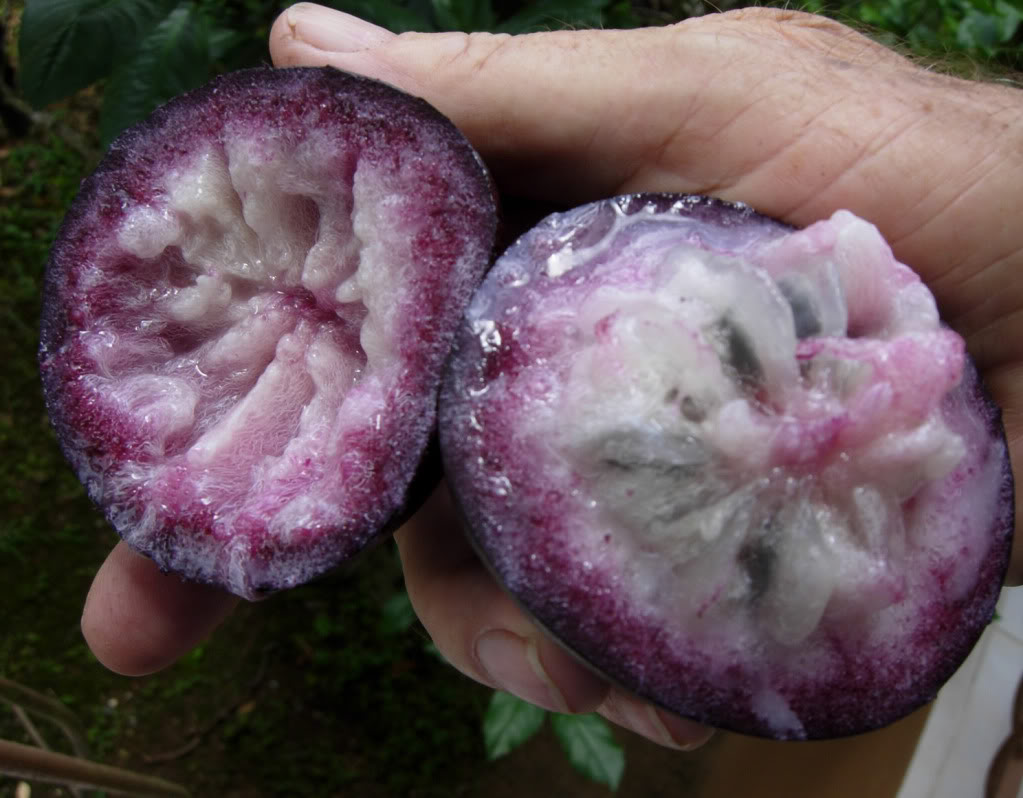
83,4,1023,746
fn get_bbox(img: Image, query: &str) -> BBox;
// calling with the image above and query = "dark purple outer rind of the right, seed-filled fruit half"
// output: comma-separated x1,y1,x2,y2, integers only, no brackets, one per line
439,194,1015,739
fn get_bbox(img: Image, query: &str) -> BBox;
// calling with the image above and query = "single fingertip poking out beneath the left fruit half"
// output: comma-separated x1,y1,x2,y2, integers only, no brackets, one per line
82,543,238,676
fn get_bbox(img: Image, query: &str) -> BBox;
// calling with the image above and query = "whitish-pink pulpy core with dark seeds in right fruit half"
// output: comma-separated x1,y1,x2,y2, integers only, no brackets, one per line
470,204,982,647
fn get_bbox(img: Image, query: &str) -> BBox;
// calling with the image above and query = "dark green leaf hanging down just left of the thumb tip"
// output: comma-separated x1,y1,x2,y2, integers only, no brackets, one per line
99,5,210,146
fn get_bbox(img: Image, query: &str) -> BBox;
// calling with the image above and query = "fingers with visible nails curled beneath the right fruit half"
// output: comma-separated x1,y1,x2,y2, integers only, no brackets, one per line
395,488,711,750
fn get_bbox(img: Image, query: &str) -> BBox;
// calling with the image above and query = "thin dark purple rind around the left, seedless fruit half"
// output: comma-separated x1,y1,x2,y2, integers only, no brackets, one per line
39,68,497,597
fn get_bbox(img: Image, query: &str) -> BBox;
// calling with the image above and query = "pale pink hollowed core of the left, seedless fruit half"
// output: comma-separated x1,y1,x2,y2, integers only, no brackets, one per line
56,120,456,594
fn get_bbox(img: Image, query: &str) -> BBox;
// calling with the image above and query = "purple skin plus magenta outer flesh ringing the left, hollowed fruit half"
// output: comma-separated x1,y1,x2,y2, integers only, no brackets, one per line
39,68,496,599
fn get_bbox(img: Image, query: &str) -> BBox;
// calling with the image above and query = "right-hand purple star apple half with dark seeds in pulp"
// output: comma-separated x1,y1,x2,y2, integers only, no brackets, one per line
439,194,1014,739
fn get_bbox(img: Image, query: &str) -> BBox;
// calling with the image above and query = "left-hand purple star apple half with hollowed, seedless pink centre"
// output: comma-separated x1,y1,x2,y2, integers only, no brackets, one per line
40,69,496,597
